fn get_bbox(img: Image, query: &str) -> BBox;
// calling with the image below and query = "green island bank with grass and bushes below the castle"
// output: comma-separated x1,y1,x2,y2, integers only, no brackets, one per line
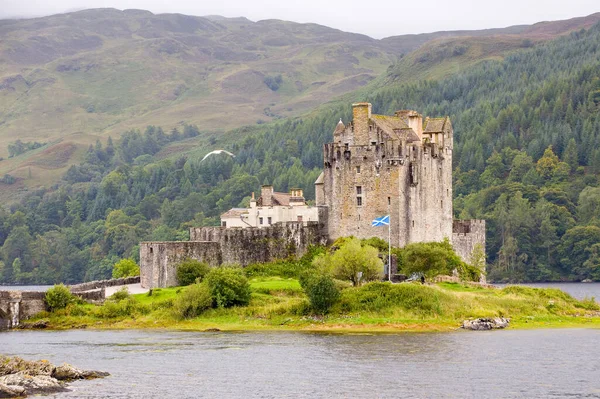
23,242,600,333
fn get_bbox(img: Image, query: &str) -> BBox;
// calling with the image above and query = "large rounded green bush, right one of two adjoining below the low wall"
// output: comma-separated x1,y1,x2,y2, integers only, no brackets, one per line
205,267,251,308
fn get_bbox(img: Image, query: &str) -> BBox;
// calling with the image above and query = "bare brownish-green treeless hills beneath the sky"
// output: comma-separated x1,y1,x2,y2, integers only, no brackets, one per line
0,9,600,198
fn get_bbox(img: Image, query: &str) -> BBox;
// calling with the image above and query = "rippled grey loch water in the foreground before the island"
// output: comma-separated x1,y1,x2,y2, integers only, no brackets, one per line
0,329,600,399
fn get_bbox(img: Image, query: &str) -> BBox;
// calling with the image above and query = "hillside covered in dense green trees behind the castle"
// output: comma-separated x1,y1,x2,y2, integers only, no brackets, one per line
0,21,600,283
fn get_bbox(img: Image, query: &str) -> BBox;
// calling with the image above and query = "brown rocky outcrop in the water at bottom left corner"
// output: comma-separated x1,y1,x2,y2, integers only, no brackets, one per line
0,355,110,398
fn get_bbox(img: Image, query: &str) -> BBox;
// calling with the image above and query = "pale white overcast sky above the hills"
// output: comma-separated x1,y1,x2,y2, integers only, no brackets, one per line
0,0,600,38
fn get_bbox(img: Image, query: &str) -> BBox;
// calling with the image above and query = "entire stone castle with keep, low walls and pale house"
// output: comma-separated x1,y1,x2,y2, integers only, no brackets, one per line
140,103,485,288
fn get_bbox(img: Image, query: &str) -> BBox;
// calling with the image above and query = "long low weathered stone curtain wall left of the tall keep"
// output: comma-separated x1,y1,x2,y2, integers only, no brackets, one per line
140,222,327,288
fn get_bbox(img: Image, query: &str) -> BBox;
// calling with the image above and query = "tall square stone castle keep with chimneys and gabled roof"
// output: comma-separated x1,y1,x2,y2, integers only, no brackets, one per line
315,103,453,247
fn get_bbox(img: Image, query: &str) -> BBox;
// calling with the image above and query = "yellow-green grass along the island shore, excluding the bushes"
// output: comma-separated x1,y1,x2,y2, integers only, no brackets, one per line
29,277,600,332
